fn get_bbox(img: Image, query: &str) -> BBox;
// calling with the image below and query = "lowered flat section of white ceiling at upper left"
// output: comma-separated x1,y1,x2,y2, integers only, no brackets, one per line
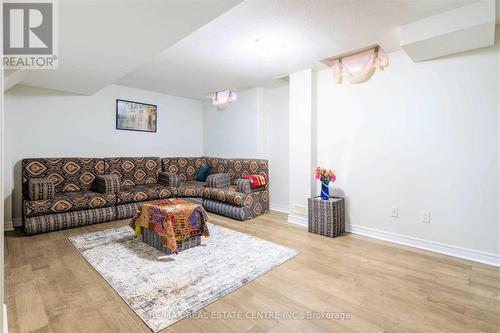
22,0,241,94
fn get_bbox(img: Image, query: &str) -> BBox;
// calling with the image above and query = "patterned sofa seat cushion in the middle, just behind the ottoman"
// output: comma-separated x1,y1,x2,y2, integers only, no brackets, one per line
117,184,177,204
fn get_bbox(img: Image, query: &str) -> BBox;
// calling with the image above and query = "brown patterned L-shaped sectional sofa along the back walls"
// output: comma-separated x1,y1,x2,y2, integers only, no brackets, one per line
22,157,269,235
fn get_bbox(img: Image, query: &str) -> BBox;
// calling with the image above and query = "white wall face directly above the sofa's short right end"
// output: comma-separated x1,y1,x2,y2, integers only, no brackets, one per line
203,88,263,158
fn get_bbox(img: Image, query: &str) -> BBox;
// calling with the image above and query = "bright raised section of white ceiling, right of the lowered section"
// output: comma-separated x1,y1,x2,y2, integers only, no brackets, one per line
118,0,474,99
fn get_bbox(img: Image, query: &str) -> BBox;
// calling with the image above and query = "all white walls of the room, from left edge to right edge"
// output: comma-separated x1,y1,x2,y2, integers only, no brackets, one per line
5,42,500,253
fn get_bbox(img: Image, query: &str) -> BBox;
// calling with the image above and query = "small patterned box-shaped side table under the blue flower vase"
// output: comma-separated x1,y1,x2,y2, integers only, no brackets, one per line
308,197,345,237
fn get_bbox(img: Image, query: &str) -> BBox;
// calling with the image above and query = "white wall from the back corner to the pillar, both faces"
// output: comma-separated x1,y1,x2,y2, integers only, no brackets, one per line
203,86,289,210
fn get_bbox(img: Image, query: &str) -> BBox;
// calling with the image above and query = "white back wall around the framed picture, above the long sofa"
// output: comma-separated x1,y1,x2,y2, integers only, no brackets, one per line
5,85,203,221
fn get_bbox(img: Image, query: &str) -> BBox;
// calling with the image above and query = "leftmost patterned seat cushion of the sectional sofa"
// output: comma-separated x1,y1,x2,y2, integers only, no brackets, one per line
24,190,116,217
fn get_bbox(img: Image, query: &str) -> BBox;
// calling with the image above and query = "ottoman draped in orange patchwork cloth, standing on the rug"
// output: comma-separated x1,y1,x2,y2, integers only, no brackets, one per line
130,199,209,255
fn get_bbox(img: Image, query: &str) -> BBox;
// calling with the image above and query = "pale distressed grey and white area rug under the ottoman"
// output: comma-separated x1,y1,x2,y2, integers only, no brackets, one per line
69,223,299,332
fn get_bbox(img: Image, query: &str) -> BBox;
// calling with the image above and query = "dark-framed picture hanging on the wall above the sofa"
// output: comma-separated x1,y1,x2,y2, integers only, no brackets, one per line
116,99,158,132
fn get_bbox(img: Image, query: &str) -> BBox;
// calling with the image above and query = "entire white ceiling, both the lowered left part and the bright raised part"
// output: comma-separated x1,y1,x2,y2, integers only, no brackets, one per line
12,0,488,99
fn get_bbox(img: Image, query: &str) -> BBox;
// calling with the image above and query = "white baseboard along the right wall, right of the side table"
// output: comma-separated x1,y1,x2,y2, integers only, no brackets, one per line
348,223,500,267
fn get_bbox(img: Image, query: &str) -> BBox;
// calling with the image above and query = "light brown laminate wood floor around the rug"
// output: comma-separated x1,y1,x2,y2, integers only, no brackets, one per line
5,212,500,333
